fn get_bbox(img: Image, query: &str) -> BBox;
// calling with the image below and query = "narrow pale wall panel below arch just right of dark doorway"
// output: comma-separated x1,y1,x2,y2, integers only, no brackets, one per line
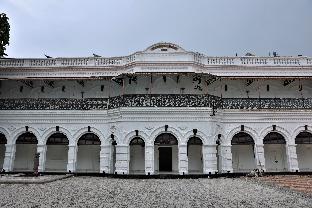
188,145,203,173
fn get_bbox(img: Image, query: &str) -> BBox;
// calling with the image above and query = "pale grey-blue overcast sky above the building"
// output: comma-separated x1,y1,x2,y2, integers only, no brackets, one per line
0,0,312,57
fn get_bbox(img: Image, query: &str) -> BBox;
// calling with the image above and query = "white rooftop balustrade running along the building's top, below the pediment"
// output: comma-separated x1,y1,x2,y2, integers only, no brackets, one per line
0,52,312,68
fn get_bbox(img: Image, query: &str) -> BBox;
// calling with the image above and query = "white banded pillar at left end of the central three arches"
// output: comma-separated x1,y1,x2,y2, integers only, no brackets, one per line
115,144,129,174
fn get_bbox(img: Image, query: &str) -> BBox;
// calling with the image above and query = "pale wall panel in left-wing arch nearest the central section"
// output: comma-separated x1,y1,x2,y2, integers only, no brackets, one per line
77,145,101,172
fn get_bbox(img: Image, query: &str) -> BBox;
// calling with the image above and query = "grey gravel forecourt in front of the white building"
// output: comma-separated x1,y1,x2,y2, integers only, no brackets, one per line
0,177,312,208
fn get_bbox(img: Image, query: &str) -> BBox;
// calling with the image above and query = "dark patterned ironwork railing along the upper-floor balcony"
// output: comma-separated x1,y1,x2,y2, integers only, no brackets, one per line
0,94,312,110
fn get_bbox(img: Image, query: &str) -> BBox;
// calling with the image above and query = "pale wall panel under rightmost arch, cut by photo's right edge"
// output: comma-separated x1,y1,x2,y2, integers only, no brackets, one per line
297,144,312,172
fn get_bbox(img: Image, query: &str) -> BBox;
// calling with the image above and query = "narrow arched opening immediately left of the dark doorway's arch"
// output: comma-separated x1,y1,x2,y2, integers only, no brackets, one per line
129,137,145,174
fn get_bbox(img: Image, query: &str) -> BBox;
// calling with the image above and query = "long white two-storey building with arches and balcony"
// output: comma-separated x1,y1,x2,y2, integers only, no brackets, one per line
0,43,312,174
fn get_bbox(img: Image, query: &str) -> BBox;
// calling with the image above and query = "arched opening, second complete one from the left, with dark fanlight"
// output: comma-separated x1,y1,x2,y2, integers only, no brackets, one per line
45,133,69,172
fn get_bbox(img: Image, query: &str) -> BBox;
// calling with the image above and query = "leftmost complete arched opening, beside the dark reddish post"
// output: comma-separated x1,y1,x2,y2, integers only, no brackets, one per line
13,132,38,171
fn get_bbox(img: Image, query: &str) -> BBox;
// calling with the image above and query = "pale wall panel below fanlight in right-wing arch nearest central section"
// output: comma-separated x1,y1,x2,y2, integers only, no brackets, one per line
231,145,256,172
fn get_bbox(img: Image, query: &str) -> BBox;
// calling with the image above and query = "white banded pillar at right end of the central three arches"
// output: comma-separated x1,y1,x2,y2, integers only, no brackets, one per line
202,144,218,174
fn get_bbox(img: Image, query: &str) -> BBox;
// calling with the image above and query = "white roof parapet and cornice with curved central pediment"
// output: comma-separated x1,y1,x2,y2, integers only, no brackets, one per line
0,43,312,79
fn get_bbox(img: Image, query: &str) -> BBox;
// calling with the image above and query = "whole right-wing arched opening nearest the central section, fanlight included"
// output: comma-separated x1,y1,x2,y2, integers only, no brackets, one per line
231,132,256,172
